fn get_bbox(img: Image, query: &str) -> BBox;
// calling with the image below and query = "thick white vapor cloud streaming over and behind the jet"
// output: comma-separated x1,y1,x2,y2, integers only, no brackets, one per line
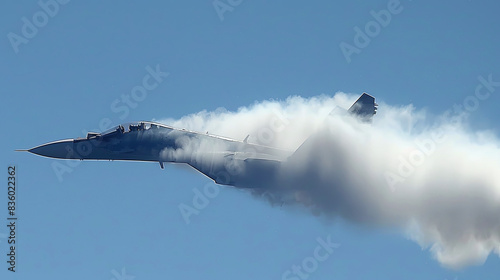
158,93,500,268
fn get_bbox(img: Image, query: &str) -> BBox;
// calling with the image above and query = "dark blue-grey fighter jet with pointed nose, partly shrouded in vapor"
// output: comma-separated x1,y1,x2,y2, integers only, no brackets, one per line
22,93,378,188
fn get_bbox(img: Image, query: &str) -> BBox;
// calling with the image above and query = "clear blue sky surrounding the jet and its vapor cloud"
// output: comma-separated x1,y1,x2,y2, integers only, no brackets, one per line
0,0,500,280
